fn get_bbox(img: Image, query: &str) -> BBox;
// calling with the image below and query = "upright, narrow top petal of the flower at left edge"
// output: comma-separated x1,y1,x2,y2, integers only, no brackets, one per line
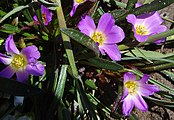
5,35,19,54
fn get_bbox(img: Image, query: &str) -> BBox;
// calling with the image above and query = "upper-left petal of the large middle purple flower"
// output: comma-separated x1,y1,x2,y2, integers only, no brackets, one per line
78,16,96,36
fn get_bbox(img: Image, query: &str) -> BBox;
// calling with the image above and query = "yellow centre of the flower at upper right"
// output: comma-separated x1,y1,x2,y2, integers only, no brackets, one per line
135,25,149,35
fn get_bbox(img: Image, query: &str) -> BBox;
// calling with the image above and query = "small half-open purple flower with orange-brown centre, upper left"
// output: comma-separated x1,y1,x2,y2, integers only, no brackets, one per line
33,5,53,25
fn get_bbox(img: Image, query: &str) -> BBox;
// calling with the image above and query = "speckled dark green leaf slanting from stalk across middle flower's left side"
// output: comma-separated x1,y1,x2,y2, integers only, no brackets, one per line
61,28,100,56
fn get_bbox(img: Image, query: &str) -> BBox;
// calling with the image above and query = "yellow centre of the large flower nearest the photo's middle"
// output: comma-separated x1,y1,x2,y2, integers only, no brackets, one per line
91,31,105,45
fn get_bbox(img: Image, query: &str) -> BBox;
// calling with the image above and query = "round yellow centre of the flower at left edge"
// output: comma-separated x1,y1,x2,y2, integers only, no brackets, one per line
11,55,27,69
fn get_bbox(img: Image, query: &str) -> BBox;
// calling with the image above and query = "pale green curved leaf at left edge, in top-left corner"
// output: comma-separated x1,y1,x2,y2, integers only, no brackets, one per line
0,5,29,23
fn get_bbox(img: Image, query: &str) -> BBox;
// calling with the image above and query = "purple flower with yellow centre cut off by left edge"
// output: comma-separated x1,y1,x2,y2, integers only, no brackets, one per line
0,35,44,82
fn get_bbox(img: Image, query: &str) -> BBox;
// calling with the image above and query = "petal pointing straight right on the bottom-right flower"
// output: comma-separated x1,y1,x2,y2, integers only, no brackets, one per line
138,84,159,96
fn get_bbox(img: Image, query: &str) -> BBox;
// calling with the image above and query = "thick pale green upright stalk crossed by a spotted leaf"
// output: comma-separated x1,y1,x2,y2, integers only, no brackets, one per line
55,0,78,79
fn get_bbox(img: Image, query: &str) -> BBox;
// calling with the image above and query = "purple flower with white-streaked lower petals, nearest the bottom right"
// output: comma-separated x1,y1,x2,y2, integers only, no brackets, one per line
122,72,159,116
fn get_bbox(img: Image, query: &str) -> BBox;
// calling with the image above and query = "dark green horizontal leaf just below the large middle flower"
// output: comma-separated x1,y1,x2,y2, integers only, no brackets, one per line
87,58,124,71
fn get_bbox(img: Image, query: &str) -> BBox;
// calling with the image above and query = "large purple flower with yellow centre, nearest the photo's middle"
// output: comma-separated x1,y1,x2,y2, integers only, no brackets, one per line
78,13,125,61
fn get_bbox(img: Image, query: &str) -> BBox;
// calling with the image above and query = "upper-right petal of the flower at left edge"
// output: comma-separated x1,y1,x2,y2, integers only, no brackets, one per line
21,45,40,60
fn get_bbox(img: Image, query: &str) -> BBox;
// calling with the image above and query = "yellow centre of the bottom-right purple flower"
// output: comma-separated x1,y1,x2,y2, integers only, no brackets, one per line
125,81,137,94
